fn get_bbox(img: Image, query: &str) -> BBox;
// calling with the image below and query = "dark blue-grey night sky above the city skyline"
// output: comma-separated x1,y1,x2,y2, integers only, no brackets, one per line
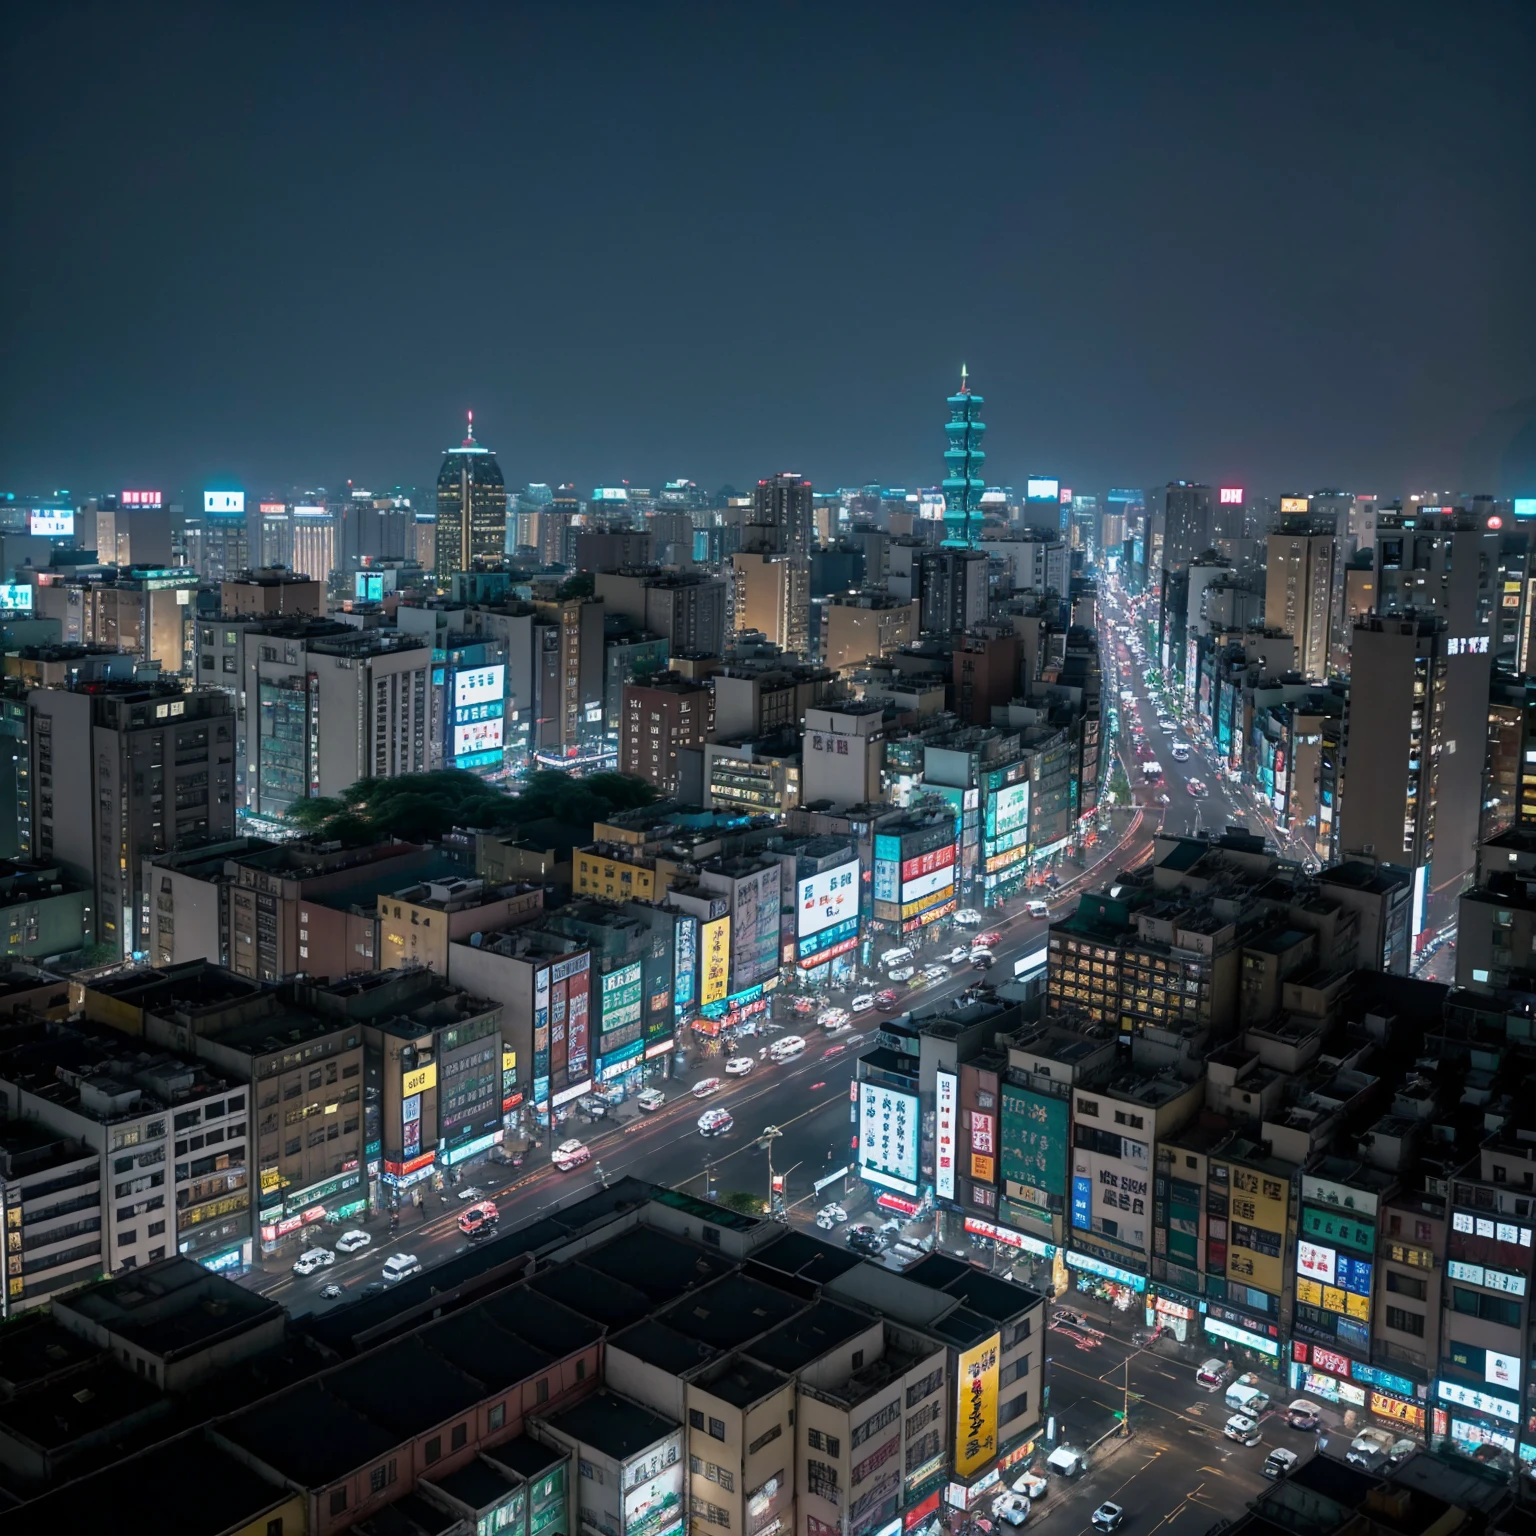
0,0,1536,495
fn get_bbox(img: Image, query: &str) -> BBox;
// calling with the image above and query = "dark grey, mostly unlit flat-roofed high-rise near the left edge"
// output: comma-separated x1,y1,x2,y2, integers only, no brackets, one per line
28,682,235,958
